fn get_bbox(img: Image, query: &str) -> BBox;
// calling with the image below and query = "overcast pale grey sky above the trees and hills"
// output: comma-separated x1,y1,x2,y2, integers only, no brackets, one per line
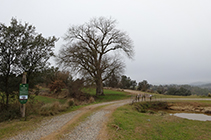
0,0,211,84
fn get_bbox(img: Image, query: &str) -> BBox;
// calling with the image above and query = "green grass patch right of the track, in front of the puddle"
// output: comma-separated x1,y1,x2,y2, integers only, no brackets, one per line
108,102,211,140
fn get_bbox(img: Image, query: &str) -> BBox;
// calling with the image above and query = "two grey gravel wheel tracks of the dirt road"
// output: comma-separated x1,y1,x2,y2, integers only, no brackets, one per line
7,100,128,140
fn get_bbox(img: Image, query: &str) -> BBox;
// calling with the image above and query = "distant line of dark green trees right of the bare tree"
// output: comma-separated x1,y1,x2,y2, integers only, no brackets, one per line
104,73,211,96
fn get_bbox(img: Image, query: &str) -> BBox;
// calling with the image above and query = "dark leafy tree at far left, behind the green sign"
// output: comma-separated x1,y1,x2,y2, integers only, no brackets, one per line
0,18,57,105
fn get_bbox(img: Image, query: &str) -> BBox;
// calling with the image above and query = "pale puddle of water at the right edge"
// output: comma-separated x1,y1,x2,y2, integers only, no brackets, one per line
170,113,211,121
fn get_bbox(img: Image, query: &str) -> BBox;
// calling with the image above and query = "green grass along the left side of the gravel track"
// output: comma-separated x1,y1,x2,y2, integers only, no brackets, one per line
0,89,130,139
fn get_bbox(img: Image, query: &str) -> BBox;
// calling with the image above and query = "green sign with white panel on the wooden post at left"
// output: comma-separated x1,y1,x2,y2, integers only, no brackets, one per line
19,84,29,104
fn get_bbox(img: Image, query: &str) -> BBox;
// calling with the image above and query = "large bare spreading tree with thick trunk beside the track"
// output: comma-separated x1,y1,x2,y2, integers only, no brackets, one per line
58,17,133,95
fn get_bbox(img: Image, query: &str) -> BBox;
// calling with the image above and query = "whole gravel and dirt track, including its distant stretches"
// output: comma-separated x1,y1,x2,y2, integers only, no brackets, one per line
5,90,211,140
